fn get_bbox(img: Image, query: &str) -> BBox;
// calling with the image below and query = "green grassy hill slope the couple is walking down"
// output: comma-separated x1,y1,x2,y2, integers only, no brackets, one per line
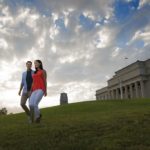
0,99,150,150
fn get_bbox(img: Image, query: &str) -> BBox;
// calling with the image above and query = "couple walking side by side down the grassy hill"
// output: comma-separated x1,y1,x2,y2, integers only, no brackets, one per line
18,60,47,123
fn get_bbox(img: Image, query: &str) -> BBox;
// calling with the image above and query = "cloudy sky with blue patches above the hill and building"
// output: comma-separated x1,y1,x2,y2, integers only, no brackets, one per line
0,0,150,113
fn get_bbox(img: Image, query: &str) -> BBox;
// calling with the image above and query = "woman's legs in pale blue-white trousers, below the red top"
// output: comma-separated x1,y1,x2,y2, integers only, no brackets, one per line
29,89,44,122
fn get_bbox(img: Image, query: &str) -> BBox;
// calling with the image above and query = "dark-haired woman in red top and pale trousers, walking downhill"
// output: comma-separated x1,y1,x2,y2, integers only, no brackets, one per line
29,60,47,123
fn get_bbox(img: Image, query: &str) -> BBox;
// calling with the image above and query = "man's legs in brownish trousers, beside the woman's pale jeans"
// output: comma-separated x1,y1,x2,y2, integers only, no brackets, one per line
20,92,30,116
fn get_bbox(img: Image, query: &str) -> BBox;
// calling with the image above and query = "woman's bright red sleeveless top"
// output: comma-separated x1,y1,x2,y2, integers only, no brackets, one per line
32,70,46,93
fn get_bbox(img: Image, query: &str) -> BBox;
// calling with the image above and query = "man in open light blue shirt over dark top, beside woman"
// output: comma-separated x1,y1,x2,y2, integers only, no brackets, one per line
18,61,34,119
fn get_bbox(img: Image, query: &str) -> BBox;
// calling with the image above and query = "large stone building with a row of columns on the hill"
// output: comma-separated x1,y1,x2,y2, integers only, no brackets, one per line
96,59,150,100
